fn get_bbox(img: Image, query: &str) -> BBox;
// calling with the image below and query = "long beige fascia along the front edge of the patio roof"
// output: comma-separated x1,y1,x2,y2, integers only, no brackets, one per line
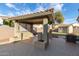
10,12,52,20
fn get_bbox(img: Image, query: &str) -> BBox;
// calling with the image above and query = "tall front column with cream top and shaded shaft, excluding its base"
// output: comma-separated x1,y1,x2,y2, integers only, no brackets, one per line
42,18,49,43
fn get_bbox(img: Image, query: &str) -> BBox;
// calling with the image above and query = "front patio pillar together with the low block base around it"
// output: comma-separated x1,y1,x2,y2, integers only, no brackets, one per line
34,18,49,49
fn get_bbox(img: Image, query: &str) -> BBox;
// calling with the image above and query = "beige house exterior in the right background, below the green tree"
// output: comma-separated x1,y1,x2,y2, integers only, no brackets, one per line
58,24,79,34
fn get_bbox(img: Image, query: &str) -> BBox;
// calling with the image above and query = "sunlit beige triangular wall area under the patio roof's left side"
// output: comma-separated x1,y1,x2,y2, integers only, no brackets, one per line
10,21,33,42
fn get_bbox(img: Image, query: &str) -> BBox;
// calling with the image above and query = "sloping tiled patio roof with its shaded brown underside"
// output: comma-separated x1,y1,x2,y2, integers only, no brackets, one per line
9,8,54,24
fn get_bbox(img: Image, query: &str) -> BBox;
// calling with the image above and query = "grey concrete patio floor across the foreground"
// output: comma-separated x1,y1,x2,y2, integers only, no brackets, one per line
0,38,79,56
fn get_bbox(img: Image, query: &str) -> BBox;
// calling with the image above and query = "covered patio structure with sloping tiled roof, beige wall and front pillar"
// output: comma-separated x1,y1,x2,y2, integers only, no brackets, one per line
9,9,54,47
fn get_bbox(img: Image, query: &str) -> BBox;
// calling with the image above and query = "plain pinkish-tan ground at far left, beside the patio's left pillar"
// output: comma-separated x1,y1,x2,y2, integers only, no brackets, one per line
0,25,13,42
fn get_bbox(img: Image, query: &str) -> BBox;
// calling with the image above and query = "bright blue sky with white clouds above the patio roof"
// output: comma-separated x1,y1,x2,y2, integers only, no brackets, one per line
0,3,79,23
